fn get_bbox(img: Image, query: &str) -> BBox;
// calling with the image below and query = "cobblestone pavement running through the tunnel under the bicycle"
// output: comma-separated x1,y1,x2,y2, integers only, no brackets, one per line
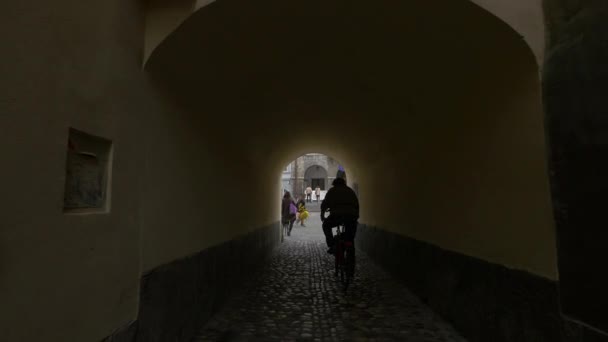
194,213,466,342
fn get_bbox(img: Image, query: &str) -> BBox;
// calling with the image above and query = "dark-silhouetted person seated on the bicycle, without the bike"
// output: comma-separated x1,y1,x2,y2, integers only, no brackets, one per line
321,178,359,254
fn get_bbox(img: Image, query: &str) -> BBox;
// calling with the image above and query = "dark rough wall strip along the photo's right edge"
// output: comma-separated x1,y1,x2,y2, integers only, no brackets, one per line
543,0,608,331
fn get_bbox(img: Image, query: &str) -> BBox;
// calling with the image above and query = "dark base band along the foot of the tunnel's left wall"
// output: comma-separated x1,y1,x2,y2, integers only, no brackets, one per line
104,223,279,342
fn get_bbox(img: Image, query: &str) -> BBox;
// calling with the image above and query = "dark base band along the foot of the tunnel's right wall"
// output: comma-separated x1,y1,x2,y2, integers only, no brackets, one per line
357,225,608,342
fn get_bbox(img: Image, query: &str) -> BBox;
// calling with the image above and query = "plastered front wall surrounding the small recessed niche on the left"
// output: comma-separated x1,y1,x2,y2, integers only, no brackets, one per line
0,1,146,342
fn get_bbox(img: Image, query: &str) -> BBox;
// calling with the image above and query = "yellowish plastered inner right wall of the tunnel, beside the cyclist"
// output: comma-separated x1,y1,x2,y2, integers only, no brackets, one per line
361,54,557,279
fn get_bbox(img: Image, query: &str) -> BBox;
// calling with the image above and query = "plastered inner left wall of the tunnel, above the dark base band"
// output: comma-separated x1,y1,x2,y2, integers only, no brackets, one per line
142,91,278,271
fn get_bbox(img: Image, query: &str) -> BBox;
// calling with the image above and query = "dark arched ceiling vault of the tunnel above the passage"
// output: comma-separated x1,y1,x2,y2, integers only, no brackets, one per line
146,0,538,190
